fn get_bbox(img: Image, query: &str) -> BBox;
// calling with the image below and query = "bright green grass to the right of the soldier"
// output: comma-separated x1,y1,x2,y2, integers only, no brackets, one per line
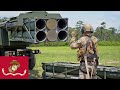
99,46,120,66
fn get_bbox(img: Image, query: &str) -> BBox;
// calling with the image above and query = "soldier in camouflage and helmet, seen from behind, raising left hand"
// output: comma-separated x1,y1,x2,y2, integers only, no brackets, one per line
70,24,98,79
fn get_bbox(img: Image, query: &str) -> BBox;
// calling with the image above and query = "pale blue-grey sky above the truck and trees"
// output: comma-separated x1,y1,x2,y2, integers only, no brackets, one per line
0,11,120,29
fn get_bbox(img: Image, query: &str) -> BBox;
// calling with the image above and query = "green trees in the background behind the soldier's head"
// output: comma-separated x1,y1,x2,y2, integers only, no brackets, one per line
69,21,120,42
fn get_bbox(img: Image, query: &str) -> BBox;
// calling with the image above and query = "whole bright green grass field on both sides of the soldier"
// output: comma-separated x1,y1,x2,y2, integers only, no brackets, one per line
27,46,120,78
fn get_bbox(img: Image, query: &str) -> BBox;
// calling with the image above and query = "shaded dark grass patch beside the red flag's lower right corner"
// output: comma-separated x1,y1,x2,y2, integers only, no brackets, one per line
29,69,42,79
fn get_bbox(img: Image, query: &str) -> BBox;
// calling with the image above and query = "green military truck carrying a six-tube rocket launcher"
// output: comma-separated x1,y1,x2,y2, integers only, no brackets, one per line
0,11,68,70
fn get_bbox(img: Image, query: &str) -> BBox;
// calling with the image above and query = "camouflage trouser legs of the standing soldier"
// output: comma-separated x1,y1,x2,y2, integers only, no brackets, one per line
79,62,97,79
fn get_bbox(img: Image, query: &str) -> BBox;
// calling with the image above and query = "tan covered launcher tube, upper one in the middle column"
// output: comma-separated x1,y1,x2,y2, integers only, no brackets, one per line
46,19,57,30
